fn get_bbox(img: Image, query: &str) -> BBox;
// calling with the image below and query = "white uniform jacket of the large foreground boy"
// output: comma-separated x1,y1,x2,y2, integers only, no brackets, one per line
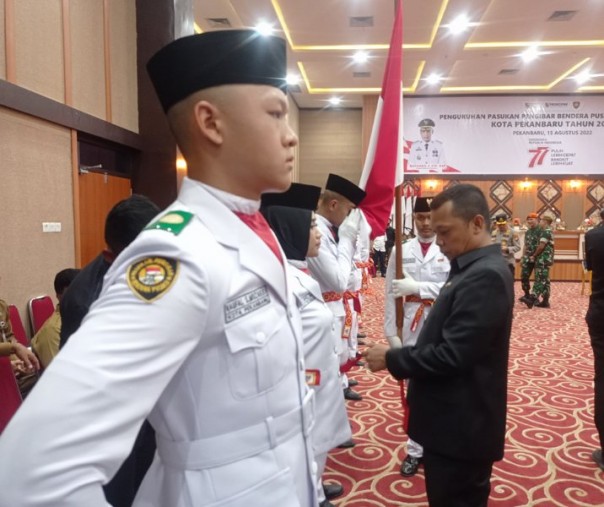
0,179,316,507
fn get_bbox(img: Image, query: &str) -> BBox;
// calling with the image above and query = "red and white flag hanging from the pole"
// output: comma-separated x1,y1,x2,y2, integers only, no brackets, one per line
359,0,403,239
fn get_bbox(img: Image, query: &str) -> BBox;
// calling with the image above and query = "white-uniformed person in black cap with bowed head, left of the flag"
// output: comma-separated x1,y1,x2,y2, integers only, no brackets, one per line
308,174,365,401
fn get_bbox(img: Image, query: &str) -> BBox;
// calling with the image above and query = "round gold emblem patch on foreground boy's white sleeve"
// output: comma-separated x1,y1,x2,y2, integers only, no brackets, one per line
128,257,178,302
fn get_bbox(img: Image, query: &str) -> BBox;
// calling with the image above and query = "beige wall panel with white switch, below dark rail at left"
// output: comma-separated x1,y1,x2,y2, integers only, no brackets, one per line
0,108,75,328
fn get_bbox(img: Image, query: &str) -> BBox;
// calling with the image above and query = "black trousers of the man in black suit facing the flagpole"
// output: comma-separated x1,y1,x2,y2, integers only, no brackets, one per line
424,449,493,507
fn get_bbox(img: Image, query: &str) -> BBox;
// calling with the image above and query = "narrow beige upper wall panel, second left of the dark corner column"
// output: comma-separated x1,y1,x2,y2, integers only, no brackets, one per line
69,0,106,119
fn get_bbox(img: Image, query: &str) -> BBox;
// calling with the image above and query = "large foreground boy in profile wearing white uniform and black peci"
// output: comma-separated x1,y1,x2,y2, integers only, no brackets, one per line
0,30,318,507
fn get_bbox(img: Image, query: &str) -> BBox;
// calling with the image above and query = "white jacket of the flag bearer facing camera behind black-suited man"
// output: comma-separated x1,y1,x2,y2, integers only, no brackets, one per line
384,238,451,347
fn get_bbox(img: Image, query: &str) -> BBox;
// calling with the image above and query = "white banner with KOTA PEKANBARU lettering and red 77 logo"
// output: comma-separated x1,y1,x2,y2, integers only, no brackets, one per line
403,95,604,177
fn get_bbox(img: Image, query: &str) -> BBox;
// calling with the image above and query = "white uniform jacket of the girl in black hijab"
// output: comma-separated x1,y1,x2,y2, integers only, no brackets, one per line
290,267,352,455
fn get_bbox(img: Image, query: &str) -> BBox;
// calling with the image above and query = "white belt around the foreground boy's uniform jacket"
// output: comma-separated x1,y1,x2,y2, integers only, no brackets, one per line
156,390,314,470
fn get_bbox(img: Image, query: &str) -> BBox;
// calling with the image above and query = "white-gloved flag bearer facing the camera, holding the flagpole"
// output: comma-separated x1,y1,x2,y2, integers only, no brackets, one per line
384,197,450,477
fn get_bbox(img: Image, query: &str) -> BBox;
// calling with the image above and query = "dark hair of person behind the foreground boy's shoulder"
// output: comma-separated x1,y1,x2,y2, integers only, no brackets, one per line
105,194,160,255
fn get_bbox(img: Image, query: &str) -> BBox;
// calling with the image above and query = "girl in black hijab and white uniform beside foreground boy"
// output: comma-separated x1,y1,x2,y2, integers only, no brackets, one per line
262,183,352,507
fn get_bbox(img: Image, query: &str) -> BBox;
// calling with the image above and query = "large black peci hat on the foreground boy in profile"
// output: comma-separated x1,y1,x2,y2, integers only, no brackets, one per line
147,30,286,112
